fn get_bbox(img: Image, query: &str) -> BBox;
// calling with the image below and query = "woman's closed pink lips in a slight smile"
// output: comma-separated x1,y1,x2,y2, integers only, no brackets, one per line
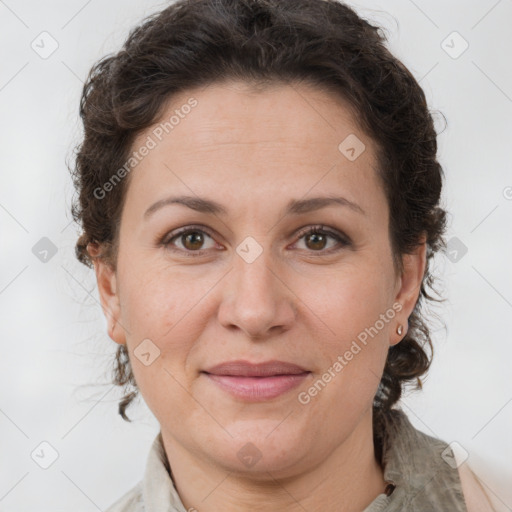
203,361,311,402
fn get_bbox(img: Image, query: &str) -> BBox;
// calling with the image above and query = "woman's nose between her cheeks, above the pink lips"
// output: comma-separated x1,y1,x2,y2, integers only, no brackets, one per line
218,249,297,339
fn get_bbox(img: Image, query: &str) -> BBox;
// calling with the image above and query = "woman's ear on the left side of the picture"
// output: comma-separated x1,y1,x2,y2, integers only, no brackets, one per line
87,243,126,345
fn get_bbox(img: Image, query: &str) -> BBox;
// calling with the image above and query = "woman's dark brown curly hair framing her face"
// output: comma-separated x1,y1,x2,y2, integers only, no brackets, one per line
71,0,446,421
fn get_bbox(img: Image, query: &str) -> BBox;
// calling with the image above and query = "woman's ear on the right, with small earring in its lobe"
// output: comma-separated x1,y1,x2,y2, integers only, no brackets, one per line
390,235,427,345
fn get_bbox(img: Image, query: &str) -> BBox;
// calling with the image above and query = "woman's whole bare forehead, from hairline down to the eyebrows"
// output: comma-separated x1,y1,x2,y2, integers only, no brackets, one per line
127,82,382,220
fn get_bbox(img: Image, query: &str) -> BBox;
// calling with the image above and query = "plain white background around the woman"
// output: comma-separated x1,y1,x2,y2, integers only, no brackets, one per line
0,0,512,512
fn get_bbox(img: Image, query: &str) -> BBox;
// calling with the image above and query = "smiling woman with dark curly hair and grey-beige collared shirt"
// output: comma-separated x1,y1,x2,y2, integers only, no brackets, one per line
73,0,491,512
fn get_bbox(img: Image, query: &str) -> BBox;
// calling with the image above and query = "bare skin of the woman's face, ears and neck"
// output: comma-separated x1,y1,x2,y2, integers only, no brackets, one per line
91,82,425,512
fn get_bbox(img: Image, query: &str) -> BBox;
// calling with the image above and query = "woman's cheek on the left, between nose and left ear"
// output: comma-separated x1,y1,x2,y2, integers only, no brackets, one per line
119,263,218,386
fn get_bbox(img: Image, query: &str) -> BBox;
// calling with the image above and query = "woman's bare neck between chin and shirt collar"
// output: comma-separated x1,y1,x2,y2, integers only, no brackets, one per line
162,410,386,512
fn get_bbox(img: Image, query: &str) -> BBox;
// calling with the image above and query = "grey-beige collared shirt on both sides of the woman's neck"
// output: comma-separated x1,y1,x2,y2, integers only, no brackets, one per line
106,409,467,512
